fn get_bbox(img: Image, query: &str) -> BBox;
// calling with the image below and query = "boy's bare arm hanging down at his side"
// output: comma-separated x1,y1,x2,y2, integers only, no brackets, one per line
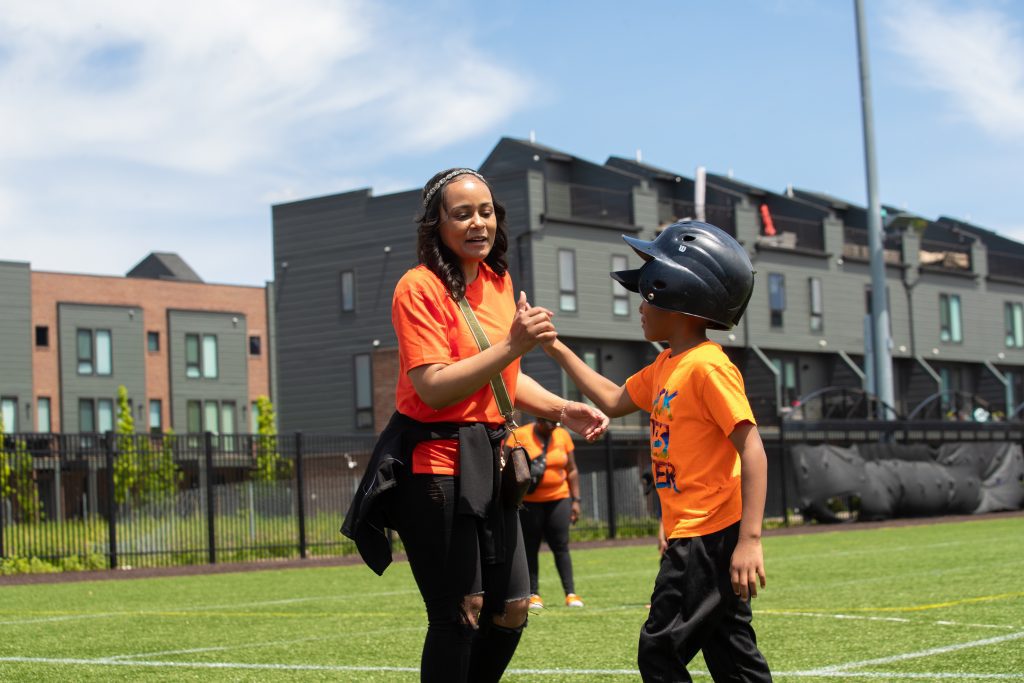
729,422,768,600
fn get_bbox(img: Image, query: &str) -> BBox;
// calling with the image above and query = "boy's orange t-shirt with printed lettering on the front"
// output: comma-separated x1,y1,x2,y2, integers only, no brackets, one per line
626,341,757,539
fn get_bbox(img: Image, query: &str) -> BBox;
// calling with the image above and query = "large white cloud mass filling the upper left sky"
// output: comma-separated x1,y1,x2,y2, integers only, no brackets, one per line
0,0,531,284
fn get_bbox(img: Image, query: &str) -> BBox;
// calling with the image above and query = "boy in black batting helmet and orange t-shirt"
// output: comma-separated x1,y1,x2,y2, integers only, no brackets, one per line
546,221,771,681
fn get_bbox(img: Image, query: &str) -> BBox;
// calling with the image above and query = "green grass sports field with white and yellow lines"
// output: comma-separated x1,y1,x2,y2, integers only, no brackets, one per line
0,516,1024,683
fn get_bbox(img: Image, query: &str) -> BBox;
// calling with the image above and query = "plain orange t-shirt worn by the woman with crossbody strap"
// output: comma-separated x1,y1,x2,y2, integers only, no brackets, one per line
391,262,519,474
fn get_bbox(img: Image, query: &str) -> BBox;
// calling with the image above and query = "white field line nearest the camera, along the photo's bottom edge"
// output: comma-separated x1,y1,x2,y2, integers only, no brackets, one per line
0,657,1024,681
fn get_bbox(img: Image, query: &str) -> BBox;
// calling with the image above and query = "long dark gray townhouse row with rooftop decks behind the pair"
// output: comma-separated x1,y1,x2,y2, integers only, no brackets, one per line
273,138,1024,433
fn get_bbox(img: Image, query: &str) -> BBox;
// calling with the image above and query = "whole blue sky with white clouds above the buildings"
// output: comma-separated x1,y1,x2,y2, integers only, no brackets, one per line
0,0,1024,285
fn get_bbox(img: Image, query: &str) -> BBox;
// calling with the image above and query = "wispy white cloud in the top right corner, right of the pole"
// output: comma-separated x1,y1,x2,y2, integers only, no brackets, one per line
886,0,1024,140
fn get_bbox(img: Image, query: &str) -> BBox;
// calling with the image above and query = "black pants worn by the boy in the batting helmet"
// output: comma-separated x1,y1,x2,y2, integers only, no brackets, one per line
637,523,771,683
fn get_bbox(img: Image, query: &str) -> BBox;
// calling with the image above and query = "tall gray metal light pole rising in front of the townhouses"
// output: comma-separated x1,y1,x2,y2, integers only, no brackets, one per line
853,0,895,419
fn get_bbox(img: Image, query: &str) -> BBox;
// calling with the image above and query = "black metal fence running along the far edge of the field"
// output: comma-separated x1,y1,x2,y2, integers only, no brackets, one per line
0,420,1024,569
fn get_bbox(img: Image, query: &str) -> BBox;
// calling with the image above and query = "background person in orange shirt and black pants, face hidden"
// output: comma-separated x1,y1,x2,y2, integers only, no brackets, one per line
509,418,583,609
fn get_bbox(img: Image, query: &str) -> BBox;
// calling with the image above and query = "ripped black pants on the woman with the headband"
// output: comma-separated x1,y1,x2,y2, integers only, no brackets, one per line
392,474,529,682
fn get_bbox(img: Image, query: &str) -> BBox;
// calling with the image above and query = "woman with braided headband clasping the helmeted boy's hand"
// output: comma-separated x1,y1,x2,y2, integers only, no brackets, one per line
387,168,608,683
